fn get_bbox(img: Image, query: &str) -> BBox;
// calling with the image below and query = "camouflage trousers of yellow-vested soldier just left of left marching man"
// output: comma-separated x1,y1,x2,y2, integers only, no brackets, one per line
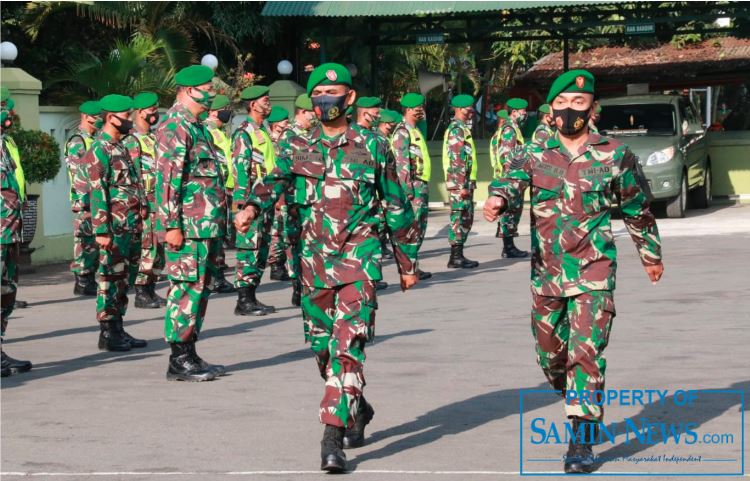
234,212,274,289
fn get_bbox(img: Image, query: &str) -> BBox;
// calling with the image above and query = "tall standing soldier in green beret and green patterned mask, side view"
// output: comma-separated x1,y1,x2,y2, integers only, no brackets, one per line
156,65,227,381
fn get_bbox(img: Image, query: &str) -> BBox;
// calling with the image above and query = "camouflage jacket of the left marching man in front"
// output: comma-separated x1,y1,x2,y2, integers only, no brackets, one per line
250,128,418,288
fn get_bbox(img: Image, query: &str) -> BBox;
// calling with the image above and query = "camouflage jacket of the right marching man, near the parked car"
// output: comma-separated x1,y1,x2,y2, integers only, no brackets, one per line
489,134,661,297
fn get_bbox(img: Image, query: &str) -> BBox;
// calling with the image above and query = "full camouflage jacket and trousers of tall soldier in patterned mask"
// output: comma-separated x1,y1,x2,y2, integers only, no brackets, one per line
156,102,227,342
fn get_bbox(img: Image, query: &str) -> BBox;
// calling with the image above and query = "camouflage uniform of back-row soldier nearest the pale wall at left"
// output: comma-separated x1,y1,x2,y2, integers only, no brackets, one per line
65,128,99,275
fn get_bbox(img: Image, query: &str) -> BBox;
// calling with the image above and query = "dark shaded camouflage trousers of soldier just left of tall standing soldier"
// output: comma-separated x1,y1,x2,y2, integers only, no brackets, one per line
96,232,141,322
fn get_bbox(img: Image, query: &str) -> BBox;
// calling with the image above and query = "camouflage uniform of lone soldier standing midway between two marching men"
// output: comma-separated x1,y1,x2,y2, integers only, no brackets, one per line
445,119,476,245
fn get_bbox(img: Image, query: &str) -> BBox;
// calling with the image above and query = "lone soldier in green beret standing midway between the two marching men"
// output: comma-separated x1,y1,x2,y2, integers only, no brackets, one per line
443,94,479,269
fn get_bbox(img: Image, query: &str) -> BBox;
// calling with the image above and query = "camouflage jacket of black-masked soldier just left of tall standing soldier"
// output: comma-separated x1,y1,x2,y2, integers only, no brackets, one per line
84,132,147,235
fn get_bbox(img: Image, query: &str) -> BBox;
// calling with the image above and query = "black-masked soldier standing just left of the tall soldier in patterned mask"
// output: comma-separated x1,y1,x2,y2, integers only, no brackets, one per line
88,94,148,351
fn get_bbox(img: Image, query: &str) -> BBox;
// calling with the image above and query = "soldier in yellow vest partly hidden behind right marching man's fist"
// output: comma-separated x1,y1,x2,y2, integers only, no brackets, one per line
490,98,529,259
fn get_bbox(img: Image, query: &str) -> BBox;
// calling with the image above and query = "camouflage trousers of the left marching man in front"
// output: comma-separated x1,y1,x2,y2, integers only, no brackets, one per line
302,281,377,427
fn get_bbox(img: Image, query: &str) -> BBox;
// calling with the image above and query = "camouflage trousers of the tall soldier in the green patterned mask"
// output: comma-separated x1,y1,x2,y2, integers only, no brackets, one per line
164,237,222,342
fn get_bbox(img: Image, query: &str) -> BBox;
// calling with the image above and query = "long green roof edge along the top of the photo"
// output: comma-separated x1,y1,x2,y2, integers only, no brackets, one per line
262,0,614,17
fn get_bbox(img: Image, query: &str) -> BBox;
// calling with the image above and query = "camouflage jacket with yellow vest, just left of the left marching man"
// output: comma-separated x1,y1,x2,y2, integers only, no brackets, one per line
232,116,275,208
